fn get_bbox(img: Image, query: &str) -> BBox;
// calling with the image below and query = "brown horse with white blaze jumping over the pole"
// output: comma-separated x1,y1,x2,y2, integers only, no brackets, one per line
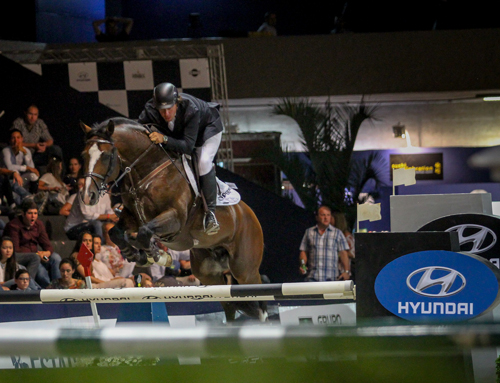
81,118,267,322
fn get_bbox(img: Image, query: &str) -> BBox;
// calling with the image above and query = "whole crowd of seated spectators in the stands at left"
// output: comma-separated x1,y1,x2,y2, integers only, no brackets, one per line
0,105,200,291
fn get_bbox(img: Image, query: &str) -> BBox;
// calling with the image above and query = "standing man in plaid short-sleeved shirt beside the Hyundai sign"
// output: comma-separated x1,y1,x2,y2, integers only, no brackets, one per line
299,206,351,282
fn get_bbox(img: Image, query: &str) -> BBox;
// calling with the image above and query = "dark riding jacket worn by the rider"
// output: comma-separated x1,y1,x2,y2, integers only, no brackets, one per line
138,93,223,154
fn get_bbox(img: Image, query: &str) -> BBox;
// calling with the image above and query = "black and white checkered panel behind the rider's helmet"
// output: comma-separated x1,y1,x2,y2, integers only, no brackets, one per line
25,58,211,119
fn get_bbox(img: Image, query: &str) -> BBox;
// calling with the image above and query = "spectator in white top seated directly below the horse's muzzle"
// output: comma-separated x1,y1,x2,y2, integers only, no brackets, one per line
60,180,119,246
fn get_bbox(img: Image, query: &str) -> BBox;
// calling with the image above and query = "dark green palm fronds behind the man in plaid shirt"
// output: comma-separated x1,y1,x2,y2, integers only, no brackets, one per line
266,98,377,226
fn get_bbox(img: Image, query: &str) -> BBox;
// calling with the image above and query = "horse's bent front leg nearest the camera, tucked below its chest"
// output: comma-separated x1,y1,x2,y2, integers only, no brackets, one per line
137,208,181,249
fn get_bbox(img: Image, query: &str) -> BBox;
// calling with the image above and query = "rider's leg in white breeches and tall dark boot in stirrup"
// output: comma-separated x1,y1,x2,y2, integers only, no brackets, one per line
196,132,222,235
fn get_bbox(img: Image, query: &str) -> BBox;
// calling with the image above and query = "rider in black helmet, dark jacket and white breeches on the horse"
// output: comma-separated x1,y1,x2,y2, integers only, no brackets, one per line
138,82,223,235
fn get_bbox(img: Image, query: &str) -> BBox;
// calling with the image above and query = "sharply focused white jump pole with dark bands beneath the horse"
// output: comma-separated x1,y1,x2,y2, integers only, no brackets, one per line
0,281,355,304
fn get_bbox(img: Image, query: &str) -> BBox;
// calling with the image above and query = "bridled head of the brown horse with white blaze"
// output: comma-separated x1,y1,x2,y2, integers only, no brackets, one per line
80,120,120,205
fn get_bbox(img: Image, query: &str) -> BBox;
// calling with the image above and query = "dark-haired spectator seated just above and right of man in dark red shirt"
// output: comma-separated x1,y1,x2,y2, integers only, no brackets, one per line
38,157,69,215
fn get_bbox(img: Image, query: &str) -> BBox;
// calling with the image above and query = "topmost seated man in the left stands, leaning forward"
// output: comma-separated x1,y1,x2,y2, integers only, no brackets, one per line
11,105,63,174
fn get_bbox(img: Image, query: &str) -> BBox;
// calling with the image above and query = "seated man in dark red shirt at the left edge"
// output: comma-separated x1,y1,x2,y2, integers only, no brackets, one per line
4,200,61,288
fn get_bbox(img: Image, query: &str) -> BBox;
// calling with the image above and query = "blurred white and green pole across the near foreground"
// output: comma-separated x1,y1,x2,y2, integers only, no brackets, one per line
0,324,488,358
